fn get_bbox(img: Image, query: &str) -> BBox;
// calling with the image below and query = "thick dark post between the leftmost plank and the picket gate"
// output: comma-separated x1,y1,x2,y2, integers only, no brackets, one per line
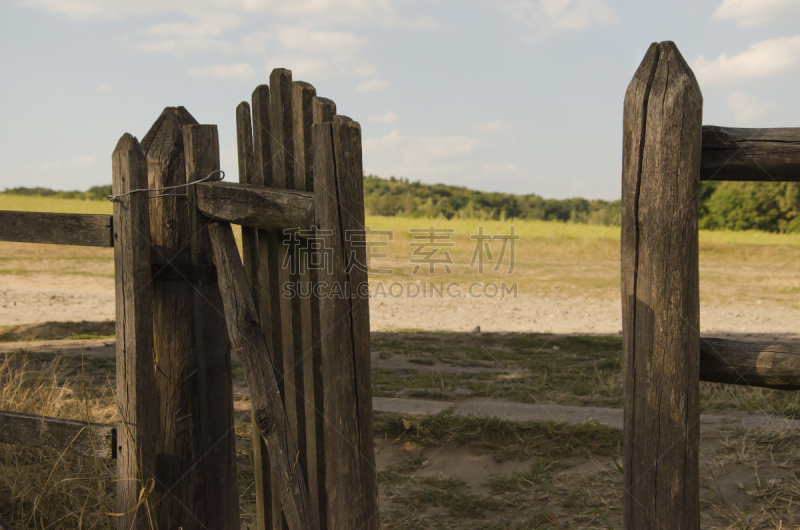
138,107,238,530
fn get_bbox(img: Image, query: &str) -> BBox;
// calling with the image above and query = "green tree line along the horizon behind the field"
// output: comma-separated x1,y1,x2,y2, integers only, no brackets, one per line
5,175,800,233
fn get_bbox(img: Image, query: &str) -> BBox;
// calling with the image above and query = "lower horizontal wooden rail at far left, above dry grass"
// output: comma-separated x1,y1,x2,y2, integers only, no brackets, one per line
0,410,117,459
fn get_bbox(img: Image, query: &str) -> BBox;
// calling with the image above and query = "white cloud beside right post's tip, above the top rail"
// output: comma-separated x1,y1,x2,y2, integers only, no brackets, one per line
694,35,800,84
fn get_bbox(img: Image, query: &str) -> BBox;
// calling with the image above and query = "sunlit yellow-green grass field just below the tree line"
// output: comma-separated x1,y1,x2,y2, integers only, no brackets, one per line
0,194,800,309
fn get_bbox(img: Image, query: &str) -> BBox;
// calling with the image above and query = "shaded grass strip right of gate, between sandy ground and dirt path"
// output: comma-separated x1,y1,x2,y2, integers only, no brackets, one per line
372,332,800,419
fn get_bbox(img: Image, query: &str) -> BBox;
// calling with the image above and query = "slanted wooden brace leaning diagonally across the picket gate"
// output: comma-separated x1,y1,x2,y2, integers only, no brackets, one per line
209,223,319,530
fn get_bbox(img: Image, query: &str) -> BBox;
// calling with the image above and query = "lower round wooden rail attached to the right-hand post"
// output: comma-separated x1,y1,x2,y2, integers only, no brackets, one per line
700,339,800,390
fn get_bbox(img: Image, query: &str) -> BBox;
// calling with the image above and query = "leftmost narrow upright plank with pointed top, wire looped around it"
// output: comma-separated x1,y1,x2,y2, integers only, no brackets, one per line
112,134,159,530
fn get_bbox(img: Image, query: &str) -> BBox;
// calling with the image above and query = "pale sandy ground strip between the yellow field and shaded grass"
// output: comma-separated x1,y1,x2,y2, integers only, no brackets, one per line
0,274,800,339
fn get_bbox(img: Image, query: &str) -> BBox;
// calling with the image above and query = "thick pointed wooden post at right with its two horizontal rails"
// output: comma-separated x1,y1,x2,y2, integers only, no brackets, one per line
621,42,800,530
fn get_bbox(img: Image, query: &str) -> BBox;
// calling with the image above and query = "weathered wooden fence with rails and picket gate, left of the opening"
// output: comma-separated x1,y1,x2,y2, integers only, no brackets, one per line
0,69,379,530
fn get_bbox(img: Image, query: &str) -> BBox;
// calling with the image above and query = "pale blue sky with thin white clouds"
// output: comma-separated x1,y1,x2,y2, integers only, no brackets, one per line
0,0,800,199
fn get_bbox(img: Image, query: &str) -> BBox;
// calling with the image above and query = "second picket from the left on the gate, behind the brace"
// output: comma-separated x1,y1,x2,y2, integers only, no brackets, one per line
250,85,283,530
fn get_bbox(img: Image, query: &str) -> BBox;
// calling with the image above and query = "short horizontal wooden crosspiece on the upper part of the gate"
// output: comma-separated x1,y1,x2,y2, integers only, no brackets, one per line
194,182,314,232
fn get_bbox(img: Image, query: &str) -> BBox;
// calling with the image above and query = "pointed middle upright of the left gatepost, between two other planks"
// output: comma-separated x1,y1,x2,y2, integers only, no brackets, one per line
142,107,206,530
